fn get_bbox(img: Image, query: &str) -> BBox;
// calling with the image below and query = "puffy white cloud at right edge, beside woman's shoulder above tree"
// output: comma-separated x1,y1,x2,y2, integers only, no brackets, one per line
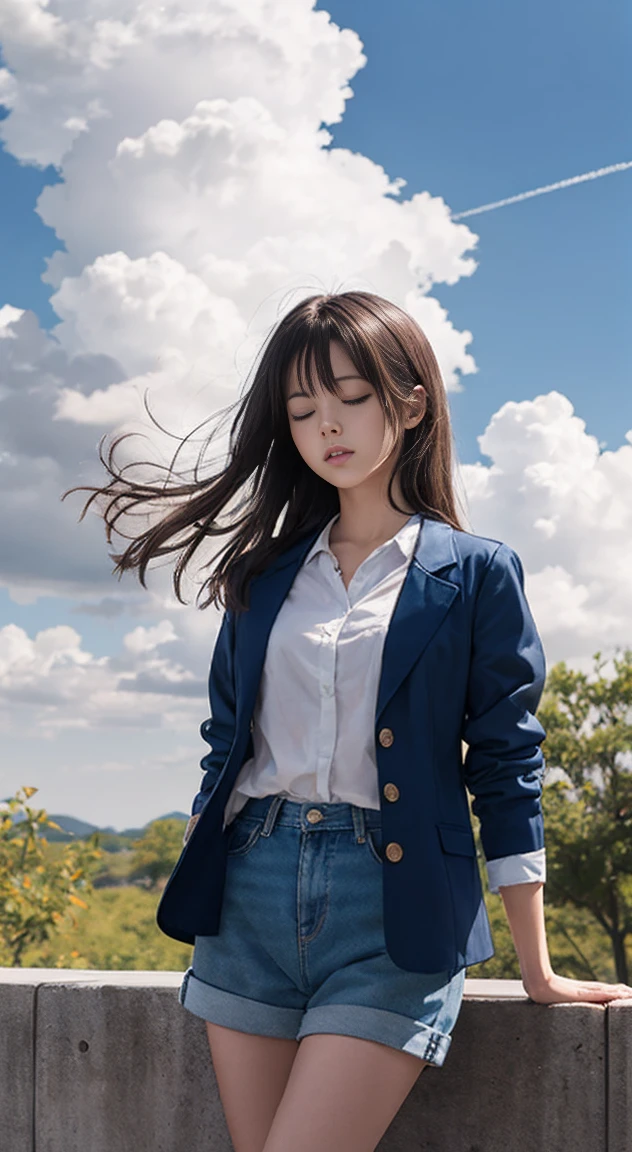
463,392,632,667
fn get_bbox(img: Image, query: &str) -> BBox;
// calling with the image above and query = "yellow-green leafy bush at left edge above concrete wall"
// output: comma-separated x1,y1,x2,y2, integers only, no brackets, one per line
0,788,102,967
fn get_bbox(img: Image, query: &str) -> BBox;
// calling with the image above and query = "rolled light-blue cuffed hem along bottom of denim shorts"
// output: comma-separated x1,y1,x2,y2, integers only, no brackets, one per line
178,969,452,1068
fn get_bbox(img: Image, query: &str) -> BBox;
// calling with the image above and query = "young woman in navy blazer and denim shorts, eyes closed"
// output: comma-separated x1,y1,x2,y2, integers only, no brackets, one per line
66,291,632,1152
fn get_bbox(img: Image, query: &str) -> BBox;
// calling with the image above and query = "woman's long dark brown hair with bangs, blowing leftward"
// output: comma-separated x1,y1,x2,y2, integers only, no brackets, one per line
62,291,467,611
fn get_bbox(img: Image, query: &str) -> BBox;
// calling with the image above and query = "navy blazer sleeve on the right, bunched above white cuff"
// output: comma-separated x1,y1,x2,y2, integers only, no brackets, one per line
462,544,546,861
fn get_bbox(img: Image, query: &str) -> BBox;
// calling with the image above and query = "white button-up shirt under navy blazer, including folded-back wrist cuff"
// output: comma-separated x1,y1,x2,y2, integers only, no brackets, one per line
224,513,545,892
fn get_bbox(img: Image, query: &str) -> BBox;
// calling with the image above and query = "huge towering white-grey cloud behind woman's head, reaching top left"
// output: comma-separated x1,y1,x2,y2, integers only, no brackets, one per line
0,0,477,598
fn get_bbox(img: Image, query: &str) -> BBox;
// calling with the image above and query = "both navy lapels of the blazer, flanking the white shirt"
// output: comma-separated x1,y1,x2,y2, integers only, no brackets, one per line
235,518,458,726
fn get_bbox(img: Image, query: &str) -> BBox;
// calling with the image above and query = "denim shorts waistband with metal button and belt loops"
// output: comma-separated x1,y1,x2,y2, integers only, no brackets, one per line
237,795,382,838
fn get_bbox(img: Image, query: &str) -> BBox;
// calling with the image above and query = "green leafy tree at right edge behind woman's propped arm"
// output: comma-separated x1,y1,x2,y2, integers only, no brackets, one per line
538,649,632,984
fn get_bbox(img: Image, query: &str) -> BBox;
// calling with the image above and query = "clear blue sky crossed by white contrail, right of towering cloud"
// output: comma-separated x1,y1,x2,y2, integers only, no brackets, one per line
321,0,632,461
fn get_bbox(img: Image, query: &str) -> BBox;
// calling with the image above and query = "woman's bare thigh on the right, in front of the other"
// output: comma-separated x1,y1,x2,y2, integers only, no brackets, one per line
264,1033,427,1152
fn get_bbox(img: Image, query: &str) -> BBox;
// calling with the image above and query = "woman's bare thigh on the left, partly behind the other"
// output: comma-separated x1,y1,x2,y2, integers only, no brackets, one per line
206,1021,298,1152
